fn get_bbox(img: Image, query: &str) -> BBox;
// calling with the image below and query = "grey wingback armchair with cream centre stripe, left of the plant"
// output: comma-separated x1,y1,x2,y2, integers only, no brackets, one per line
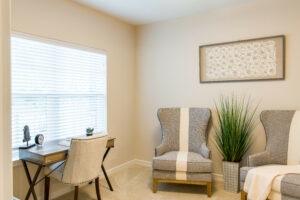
152,108,212,197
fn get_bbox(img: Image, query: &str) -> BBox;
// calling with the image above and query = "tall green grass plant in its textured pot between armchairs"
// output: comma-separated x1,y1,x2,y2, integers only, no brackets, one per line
214,95,257,192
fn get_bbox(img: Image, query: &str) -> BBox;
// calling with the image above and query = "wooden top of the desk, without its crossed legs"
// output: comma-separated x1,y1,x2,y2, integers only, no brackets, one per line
19,138,115,165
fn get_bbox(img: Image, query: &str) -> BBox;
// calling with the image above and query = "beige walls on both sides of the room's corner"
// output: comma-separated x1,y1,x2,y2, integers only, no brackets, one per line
12,0,300,198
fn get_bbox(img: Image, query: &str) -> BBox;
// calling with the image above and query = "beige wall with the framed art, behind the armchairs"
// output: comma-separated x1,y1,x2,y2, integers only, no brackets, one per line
136,0,300,173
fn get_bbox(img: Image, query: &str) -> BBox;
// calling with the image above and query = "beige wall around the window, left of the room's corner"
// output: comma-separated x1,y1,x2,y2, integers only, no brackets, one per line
12,0,136,199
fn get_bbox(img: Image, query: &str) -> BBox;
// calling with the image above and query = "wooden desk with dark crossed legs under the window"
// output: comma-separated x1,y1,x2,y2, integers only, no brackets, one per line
19,138,116,200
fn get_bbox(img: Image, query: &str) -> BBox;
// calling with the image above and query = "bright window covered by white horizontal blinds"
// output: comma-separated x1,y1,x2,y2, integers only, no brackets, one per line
11,34,107,148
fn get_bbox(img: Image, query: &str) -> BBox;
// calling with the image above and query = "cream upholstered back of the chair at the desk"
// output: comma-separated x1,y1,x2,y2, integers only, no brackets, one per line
62,134,107,185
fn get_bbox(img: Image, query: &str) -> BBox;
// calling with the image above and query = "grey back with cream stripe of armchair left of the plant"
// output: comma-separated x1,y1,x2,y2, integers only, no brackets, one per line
157,108,211,153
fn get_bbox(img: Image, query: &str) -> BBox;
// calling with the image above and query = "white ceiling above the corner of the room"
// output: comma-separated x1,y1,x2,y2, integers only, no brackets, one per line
73,0,251,25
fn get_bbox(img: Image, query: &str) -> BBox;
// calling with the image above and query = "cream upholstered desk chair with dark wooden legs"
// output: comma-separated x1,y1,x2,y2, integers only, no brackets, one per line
45,134,107,200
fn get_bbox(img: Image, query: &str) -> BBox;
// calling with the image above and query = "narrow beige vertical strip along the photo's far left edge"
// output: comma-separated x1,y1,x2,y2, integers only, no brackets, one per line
0,0,12,200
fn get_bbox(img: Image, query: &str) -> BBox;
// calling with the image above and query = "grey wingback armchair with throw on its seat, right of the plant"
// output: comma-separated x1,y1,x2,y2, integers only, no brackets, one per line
240,110,300,200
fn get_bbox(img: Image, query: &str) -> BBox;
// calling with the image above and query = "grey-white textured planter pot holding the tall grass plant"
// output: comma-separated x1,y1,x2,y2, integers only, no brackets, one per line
223,161,240,193
